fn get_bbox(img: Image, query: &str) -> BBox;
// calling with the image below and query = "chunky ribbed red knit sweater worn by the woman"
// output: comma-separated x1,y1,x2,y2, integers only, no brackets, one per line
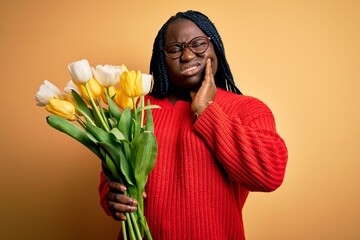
99,89,287,240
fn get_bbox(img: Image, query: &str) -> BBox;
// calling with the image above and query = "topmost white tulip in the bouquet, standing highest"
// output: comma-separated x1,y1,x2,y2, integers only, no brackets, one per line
68,59,92,84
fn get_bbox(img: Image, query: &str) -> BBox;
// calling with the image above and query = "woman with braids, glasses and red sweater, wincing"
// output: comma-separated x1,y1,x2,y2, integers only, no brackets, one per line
99,11,287,240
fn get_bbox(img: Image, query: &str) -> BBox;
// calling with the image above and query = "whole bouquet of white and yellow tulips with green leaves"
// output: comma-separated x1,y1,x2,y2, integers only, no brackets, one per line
35,59,158,239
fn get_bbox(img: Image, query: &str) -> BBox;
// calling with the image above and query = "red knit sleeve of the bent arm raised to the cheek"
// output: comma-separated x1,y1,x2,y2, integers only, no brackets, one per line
194,94,288,192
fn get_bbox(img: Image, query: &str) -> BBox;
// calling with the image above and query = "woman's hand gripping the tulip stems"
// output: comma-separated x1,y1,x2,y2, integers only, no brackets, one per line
106,182,138,221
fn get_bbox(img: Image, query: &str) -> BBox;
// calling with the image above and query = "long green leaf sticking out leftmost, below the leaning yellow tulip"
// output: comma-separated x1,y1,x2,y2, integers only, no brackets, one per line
46,115,102,159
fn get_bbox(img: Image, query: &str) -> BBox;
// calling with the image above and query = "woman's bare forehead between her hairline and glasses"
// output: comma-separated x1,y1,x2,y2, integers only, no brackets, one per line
164,19,206,44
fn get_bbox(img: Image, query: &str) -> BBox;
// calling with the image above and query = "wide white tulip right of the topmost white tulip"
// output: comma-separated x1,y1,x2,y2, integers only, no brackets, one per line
92,65,123,88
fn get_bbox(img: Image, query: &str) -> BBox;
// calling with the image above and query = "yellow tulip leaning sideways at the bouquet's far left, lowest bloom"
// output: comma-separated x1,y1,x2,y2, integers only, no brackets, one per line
45,98,76,121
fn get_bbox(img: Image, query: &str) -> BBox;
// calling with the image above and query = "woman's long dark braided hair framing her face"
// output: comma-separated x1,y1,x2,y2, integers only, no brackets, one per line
150,10,242,98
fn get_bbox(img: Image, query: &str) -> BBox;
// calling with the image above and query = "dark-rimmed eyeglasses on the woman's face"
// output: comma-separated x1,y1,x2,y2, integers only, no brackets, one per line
163,36,211,59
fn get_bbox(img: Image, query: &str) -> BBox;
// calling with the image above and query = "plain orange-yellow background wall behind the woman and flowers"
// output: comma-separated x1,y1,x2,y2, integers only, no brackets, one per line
0,0,360,240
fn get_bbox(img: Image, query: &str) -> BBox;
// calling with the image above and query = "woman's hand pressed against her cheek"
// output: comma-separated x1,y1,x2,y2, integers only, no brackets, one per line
190,59,217,116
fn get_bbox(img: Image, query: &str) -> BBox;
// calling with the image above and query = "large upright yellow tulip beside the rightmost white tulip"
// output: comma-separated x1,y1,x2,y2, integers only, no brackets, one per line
119,71,142,98
